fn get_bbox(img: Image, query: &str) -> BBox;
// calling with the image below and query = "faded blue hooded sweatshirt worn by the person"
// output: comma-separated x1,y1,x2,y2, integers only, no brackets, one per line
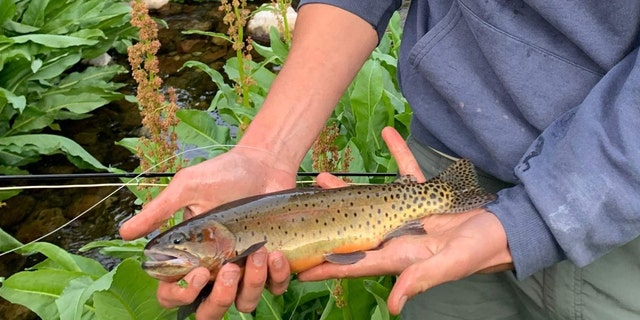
301,0,640,278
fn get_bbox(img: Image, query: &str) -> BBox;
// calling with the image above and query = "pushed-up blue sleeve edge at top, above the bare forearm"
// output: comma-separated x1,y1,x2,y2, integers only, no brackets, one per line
298,0,402,41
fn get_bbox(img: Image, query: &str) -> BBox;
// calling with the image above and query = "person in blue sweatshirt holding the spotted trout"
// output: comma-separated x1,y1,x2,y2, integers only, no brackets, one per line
120,0,640,319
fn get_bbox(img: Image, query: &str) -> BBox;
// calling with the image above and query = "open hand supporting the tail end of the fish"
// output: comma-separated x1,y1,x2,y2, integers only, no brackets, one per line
298,129,513,314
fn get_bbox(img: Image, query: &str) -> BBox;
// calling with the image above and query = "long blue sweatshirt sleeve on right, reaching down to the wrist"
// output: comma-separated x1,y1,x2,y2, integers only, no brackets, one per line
487,48,640,278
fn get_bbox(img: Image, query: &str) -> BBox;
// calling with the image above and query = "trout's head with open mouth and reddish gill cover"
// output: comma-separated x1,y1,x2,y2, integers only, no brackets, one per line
142,219,235,282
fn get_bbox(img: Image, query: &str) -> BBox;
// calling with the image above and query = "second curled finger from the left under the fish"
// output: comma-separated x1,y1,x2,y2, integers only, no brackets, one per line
196,263,241,320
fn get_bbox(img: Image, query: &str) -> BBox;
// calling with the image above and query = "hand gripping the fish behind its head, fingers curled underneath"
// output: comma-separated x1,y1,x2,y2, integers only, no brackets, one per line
120,147,297,319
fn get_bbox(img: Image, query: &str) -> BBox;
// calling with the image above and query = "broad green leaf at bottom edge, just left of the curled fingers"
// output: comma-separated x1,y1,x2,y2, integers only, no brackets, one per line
93,259,176,320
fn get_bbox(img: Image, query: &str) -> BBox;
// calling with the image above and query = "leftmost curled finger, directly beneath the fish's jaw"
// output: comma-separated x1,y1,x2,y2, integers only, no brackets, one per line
158,268,209,308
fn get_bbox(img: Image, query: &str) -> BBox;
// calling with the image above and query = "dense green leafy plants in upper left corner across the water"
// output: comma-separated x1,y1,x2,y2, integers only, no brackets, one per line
0,0,135,201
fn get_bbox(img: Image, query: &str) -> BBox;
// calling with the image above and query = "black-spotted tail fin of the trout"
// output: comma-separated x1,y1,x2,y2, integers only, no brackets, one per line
435,159,496,212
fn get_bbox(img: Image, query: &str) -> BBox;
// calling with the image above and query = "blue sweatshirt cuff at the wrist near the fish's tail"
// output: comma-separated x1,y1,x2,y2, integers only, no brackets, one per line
485,185,566,279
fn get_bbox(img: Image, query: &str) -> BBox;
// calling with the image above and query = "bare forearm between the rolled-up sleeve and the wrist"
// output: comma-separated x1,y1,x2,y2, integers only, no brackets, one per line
239,4,378,170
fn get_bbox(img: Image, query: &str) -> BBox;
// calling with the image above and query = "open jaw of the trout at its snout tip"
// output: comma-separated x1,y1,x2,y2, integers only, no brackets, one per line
142,249,200,282
